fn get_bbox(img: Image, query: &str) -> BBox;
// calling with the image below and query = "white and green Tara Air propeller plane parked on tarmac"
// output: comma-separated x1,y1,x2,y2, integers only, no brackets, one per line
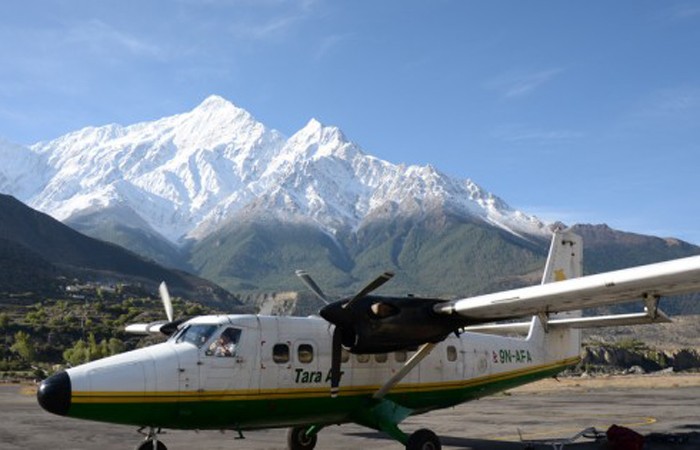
37,230,700,450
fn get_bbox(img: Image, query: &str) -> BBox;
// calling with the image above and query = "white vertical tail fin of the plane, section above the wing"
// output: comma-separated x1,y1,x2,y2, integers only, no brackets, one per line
542,229,583,284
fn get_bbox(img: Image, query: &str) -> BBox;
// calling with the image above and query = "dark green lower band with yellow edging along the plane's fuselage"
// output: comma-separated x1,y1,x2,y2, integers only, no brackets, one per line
68,358,578,430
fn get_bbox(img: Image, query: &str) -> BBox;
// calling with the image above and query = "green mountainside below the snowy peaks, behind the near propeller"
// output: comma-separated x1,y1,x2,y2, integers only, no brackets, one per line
190,214,548,296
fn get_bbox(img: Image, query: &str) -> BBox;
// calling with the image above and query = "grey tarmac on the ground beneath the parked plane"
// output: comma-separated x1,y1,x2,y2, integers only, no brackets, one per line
0,374,700,450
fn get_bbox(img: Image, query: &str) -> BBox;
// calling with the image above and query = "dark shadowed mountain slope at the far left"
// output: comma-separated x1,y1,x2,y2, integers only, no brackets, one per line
0,195,237,304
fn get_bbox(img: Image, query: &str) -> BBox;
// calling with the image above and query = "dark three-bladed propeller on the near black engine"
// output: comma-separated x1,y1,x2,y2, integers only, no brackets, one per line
296,270,394,397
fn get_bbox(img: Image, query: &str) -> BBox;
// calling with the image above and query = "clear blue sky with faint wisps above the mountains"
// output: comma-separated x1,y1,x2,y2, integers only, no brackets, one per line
0,0,700,244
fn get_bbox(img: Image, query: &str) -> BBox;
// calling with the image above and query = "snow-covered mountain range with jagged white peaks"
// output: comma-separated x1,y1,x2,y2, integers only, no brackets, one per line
0,92,549,245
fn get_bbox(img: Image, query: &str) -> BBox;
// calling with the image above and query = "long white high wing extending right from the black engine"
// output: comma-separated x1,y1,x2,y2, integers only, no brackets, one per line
434,256,700,323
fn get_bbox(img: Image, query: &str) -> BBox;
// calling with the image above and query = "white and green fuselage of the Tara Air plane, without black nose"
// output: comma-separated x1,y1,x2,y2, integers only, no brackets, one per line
42,315,580,430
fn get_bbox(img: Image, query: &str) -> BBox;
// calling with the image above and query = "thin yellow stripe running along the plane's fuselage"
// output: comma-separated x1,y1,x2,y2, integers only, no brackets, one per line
72,357,580,404
